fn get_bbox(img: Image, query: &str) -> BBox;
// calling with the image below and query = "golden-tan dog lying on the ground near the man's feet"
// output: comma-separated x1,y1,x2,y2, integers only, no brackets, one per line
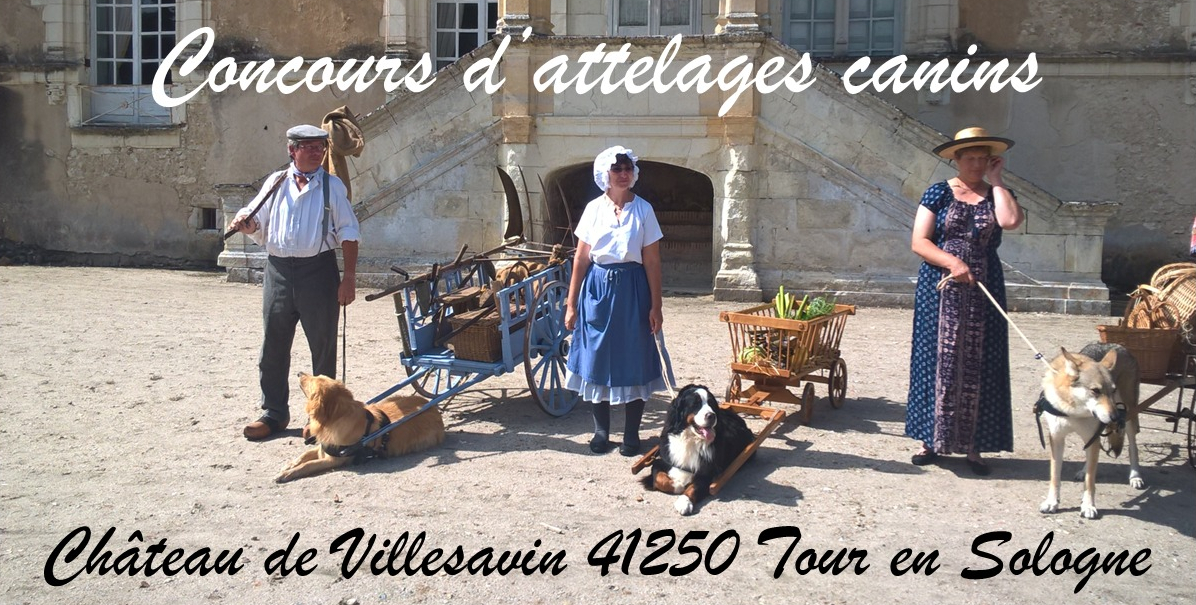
274,373,445,483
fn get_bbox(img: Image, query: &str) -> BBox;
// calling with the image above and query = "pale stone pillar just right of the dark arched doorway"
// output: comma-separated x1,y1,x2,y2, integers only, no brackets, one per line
714,141,764,303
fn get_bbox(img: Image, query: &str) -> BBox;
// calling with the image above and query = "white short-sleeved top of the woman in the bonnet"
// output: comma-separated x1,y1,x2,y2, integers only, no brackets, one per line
574,194,665,264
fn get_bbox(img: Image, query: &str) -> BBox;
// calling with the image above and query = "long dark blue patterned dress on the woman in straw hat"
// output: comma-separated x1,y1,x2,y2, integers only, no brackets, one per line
905,181,1013,454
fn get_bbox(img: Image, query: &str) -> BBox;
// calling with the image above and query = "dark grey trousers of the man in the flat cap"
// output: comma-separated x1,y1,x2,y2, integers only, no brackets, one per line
257,250,341,424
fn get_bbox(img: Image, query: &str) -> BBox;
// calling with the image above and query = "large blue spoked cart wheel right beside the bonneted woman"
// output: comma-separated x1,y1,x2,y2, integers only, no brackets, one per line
524,280,579,416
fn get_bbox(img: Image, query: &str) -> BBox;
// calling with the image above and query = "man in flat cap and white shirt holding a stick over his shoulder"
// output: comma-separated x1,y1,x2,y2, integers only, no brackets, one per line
231,124,361,441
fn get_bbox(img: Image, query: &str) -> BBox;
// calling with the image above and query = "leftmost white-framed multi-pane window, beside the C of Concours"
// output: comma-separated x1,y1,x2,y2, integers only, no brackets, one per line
83,0,175,126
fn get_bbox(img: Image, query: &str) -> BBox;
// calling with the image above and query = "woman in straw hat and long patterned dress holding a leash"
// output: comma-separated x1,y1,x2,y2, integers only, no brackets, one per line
905,127,1025,475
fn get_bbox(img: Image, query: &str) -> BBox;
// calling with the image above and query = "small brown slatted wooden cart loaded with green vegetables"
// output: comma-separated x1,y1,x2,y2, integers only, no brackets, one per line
719,303,855,423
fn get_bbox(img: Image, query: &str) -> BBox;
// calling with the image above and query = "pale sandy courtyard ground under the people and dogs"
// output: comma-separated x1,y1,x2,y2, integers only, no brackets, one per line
0,267,1196,604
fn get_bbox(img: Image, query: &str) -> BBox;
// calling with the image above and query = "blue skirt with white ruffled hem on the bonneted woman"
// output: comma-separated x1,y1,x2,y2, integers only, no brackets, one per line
566,263,665,404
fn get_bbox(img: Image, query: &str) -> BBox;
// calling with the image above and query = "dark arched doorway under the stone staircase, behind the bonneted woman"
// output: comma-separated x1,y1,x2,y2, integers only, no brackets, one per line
547,160,715,292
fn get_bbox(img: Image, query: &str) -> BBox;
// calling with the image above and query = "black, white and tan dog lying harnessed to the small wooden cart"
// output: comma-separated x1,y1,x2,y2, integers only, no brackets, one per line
645,385,756,514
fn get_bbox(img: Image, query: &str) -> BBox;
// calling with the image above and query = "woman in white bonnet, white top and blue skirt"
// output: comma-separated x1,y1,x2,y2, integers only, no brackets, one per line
565,146,665,456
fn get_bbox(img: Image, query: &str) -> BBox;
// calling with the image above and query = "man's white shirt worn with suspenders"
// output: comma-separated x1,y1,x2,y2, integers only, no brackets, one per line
237,164,361,257
